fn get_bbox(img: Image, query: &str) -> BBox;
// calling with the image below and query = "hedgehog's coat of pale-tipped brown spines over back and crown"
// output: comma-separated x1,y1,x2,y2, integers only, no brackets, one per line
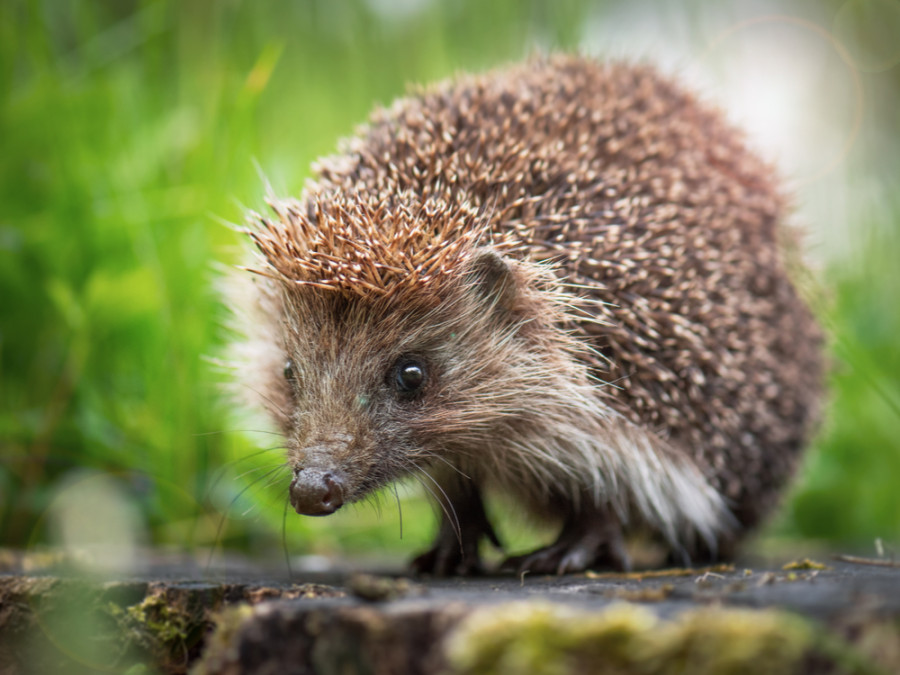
239,58,821,572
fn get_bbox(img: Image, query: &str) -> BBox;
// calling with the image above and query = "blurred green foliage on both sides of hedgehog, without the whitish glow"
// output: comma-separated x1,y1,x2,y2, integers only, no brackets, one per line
0,0,900,564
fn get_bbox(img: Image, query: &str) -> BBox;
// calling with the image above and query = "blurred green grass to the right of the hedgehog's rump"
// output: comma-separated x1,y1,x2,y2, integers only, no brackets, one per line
785,201,900,542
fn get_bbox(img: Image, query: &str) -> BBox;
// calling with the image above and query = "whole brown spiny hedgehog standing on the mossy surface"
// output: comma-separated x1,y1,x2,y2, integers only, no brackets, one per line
232,55,822,575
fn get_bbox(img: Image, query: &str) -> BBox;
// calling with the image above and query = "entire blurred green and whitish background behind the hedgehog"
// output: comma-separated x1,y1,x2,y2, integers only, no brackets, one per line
0,0,900,572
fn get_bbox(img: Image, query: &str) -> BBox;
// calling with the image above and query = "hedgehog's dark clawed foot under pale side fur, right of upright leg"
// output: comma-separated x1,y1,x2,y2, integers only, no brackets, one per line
501,505,631,574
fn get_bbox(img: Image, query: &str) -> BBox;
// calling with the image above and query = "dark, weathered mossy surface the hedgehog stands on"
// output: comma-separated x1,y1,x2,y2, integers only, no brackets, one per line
0,553,900,674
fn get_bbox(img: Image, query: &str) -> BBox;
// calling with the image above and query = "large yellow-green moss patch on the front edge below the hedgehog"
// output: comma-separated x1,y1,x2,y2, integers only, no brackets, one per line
447,603,880,675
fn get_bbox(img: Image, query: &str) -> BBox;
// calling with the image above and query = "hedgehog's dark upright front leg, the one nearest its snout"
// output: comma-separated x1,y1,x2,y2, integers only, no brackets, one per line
412,477,502,577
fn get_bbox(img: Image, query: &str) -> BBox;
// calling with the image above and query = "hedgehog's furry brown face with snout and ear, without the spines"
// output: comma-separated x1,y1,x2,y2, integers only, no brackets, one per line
265,248,584,515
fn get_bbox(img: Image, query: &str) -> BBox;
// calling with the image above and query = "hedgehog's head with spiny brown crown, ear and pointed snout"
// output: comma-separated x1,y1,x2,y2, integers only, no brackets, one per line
243,194,592,515
